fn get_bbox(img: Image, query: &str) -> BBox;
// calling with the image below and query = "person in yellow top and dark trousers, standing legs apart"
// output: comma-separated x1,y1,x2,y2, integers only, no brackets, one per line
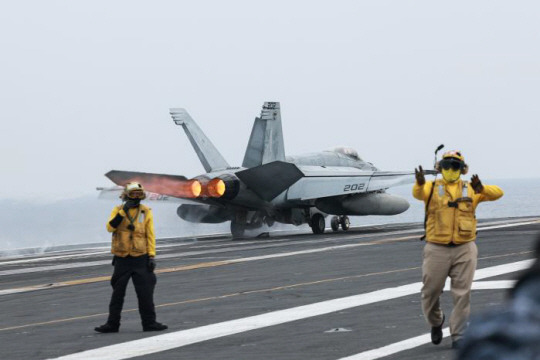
94,182,167,333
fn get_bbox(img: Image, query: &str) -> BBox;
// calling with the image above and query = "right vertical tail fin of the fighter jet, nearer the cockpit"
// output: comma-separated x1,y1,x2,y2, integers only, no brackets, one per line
242,102,285,168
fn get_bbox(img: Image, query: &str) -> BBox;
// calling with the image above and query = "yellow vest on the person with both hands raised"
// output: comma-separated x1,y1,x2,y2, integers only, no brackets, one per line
426,180,476,244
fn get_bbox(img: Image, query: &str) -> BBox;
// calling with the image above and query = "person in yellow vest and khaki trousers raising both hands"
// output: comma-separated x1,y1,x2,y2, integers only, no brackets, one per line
413,151,503,348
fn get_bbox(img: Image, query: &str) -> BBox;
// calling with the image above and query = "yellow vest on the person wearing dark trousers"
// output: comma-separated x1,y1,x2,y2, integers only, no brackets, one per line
111,204,150,257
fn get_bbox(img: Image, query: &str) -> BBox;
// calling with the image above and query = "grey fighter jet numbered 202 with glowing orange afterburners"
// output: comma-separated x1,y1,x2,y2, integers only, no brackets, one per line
104,102,422,238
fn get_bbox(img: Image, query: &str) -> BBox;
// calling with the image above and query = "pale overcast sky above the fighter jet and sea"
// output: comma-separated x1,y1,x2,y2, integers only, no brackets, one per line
0,0,540,198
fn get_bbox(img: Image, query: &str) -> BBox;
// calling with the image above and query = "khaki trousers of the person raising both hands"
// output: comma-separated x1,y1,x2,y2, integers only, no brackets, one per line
422,241,478,341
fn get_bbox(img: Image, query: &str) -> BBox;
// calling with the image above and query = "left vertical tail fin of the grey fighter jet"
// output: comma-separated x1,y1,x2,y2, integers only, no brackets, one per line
169,108,229,172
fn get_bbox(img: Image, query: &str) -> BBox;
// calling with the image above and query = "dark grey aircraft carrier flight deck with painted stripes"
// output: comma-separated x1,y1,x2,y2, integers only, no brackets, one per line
0,217,540,360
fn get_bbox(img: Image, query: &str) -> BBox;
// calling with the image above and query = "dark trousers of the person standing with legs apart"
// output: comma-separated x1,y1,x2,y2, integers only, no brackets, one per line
107,255,156,326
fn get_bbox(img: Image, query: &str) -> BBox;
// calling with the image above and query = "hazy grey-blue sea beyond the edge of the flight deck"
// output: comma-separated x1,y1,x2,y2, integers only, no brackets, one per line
0,179,540,255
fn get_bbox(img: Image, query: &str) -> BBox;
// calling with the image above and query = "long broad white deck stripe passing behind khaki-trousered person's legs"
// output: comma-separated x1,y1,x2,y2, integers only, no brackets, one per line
49,260,533,360
